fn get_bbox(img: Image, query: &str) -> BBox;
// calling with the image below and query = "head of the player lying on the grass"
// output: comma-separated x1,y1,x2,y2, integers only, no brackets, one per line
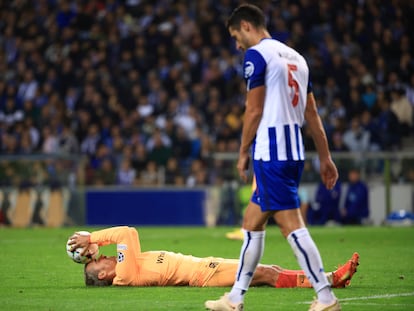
84,256,116,286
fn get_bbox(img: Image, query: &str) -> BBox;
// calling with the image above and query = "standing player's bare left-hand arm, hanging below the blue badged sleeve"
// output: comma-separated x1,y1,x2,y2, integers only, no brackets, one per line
237,86,266,182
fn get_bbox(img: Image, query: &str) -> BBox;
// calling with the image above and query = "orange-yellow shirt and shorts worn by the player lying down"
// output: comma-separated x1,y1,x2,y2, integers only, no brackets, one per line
90,226,238,287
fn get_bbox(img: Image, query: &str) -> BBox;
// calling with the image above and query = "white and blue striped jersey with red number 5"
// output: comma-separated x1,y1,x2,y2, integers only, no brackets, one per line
244,39,311,161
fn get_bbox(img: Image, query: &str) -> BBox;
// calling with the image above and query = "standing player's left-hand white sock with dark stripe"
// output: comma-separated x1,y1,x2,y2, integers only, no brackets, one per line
228,230,265,303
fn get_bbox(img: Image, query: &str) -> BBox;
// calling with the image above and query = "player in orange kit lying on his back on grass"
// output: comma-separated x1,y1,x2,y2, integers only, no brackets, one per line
71,226,359,288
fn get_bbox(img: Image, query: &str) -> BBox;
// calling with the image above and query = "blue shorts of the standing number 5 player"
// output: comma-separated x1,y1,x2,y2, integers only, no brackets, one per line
251,160,304,212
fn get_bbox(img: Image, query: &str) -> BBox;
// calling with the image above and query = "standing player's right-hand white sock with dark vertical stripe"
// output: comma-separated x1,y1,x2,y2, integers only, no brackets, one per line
287,228,336,304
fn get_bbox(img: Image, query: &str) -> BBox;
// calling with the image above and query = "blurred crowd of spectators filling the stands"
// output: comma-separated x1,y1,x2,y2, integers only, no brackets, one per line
0,0,414,186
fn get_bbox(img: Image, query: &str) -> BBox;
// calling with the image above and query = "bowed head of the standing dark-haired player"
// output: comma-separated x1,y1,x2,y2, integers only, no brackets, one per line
226,4,266,51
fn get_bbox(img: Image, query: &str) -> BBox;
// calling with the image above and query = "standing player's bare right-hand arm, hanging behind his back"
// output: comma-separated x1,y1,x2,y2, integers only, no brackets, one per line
305,92,338,189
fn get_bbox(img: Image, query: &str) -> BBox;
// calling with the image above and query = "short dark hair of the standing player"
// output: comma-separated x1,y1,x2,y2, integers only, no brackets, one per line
226,3,266,29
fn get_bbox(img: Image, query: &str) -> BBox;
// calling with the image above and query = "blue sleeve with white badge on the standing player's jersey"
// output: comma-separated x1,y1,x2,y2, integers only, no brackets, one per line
244,49,266,91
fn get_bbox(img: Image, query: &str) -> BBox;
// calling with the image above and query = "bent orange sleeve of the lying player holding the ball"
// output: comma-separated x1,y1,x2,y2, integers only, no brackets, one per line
90,226,141,285
